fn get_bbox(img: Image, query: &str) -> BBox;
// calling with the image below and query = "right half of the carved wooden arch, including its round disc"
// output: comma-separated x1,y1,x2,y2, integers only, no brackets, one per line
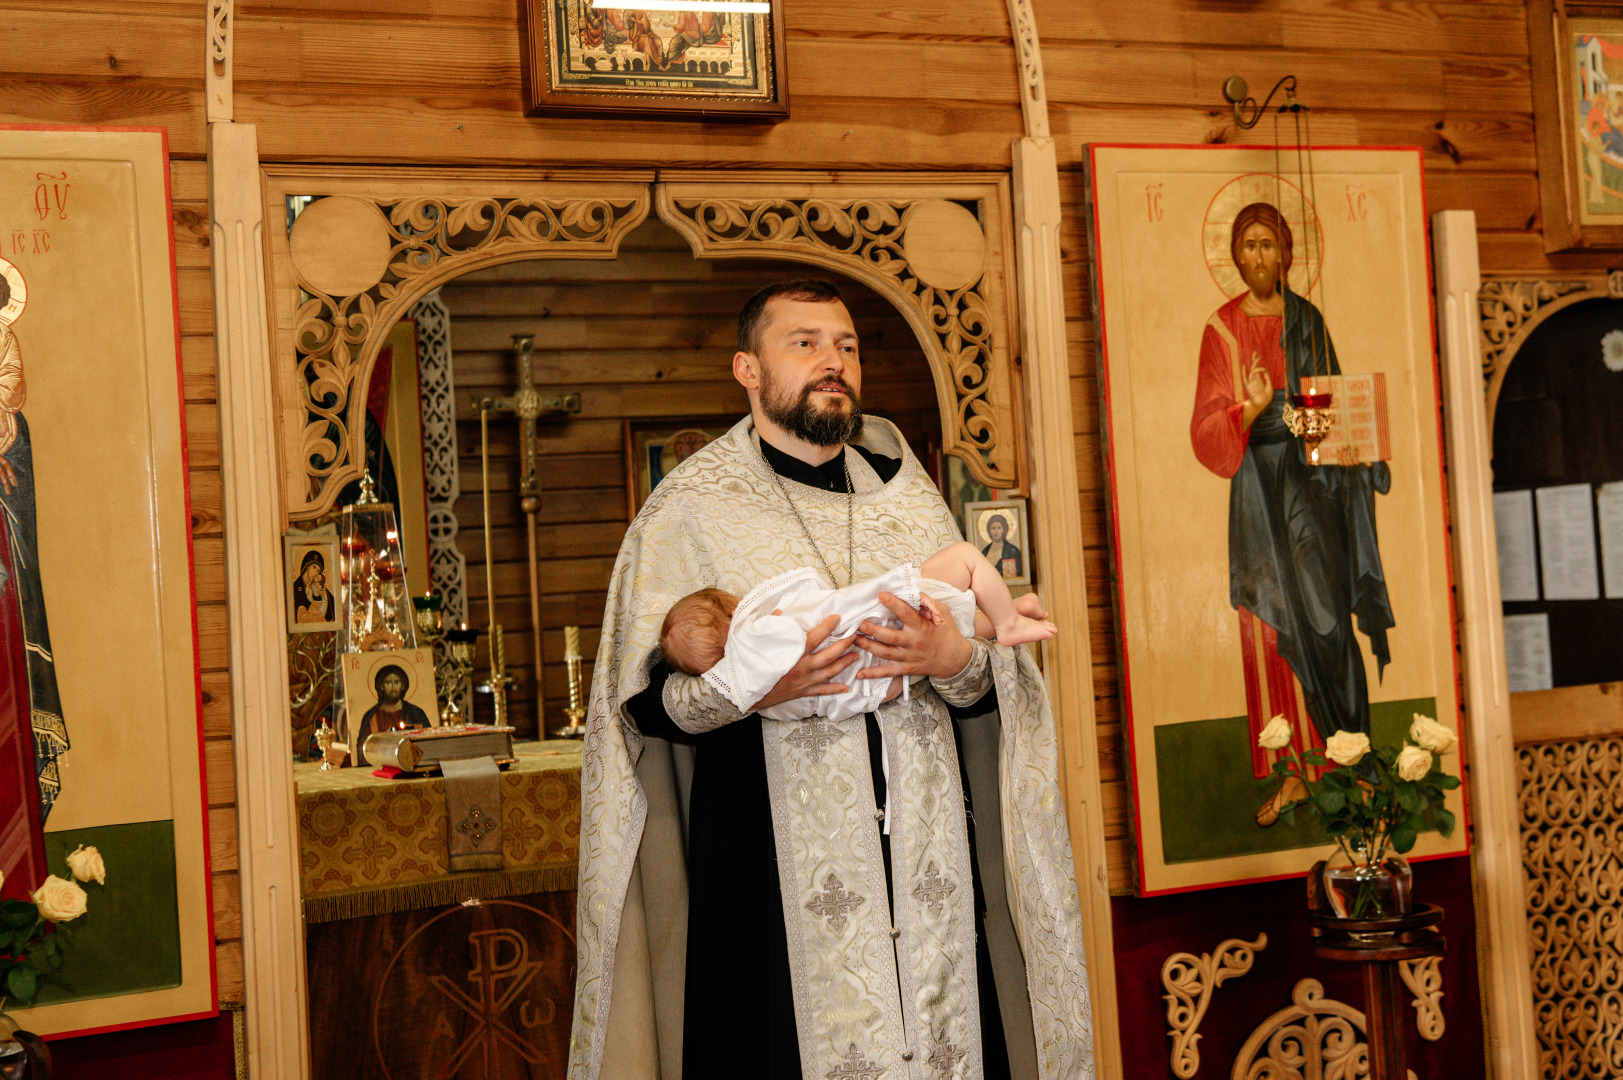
656,174,1026,492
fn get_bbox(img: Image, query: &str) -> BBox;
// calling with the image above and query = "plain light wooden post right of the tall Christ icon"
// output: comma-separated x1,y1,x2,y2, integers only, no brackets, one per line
1431,210,1539,1077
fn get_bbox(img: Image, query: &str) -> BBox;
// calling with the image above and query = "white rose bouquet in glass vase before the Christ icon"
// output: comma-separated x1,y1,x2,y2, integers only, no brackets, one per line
1256,713,1459,919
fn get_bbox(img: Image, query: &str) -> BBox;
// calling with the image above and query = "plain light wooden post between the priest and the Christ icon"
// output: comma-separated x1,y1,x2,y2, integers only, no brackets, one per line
1013,138,1123,1080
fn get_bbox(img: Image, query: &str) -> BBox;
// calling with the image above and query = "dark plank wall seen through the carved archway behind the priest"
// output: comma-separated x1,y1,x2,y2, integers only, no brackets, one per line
441,219,941,737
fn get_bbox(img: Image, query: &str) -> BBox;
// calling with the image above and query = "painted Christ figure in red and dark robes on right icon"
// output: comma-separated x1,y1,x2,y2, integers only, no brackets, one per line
1190,203,1393,792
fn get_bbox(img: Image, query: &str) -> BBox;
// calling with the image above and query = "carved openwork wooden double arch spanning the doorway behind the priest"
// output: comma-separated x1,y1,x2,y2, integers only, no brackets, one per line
266,167,1026,521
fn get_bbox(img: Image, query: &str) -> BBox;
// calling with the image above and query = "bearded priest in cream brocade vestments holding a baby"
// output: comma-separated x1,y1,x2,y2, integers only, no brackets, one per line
570,281,1092,1080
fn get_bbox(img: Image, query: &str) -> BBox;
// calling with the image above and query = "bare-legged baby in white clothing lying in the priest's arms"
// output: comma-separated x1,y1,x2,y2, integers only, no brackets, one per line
659,542,1057,719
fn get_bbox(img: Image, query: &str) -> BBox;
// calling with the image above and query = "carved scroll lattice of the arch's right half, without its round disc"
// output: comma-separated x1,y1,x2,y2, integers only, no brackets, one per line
659,184,1021,487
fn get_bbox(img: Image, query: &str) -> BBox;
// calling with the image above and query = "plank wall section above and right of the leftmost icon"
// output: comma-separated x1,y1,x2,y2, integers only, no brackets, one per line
0,0,242,1004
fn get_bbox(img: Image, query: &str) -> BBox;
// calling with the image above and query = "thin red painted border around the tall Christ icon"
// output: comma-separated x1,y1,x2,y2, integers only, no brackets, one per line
1087,143,1470,896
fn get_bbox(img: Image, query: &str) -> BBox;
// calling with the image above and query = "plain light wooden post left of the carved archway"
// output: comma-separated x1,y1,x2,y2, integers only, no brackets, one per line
208,123,310,1080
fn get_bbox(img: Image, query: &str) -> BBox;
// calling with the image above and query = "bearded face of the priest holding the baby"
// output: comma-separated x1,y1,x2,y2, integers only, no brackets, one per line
745,297,862,447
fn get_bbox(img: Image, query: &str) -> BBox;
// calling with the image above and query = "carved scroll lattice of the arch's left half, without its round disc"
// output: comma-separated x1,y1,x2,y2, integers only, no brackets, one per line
289,184,648,520
